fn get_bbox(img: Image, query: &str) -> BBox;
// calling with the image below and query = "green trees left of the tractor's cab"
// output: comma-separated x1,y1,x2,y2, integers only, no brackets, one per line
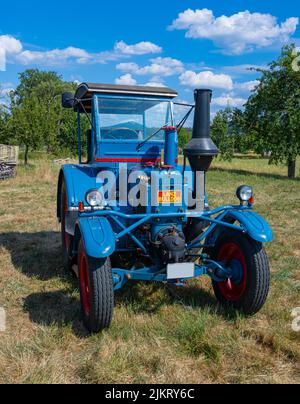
0,69,85,165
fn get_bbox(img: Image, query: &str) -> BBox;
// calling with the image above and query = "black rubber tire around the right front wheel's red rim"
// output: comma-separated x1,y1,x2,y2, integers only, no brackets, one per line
210,230,270,316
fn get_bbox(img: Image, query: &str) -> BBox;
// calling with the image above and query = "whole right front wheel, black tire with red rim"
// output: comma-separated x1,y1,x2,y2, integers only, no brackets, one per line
211,230,270,315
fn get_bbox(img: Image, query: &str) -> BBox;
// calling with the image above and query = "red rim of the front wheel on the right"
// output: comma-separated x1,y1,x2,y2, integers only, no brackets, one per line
218,243,248,302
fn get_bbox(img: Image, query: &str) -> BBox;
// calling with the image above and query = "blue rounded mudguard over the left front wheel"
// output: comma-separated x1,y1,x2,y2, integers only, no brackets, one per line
78,217,116,258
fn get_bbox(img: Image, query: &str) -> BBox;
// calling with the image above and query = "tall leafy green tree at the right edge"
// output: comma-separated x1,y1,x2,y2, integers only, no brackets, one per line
245,45,300,178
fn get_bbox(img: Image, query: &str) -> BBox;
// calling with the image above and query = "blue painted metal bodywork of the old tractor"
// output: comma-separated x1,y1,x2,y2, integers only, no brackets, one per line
58,91,273,290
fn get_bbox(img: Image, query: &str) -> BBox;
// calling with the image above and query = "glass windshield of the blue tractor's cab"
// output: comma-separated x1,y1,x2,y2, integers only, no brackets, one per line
98,97,174,141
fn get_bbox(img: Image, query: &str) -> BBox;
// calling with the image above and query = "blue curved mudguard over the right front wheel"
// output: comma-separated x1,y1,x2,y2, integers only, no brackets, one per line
207,210,274,244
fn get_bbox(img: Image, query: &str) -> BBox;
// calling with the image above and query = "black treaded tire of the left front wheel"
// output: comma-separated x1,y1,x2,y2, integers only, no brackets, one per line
78,240,114,333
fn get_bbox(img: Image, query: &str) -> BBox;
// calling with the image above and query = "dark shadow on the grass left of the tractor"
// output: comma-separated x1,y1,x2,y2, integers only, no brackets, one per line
0,232,87,337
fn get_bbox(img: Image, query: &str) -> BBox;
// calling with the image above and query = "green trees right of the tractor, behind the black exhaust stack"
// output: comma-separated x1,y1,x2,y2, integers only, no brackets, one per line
180,45,300,178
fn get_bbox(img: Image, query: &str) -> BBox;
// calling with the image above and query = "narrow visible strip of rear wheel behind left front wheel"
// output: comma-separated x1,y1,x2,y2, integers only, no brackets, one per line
60,181,73,270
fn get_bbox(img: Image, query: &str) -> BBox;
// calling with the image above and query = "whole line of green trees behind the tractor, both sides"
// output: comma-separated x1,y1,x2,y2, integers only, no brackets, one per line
0,45,300,178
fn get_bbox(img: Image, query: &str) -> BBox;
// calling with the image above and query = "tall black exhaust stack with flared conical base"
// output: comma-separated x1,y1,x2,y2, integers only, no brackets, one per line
184,90,219,172
